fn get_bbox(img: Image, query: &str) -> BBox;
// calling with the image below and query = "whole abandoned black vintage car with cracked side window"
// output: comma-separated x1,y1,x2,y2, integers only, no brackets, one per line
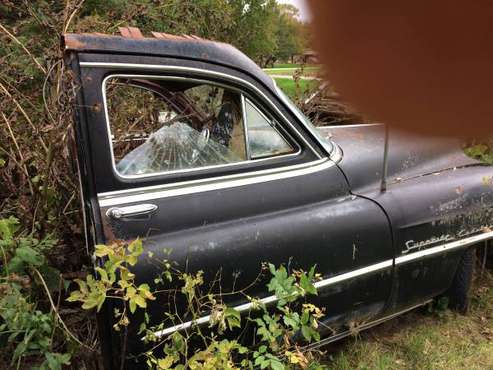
64,33,493,366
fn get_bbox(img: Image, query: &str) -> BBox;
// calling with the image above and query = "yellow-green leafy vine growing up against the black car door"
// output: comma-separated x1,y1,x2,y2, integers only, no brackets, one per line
68,239,324,370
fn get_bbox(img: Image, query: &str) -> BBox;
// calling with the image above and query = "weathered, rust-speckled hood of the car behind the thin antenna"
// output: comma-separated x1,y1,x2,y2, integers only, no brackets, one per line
319,124,480,193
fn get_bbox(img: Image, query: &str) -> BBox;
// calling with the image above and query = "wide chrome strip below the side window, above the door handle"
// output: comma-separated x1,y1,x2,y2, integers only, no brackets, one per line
98,158,335,208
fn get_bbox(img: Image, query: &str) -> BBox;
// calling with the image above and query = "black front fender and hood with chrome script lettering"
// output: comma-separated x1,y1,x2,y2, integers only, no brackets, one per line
321,125,493,310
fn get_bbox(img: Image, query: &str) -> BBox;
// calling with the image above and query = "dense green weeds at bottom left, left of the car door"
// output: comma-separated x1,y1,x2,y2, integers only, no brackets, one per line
0,217,98,369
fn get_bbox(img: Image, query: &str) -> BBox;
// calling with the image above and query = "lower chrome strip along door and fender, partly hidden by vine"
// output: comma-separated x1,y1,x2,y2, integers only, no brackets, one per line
142,231,493,339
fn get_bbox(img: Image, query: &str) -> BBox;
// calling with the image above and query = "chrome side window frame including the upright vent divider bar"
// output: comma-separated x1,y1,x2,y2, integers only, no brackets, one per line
101,73,304,180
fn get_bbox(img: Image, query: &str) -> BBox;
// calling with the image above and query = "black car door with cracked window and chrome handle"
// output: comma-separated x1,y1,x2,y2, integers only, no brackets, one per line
71,48,393,368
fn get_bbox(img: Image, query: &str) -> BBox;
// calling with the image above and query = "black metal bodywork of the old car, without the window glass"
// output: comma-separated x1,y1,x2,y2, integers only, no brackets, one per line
65,35,493,366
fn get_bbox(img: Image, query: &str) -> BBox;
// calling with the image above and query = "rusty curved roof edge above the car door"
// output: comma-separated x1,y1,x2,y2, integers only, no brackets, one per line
62,27,274,89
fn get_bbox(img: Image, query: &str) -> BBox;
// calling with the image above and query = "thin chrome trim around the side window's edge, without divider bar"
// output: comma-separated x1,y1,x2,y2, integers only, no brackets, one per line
101,73,304,180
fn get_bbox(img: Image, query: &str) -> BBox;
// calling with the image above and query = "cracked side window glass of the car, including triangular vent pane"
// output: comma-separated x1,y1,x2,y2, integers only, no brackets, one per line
104,76,294,177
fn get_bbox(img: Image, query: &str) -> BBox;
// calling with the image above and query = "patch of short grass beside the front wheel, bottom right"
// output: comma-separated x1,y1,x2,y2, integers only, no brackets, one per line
325,272,493,370
